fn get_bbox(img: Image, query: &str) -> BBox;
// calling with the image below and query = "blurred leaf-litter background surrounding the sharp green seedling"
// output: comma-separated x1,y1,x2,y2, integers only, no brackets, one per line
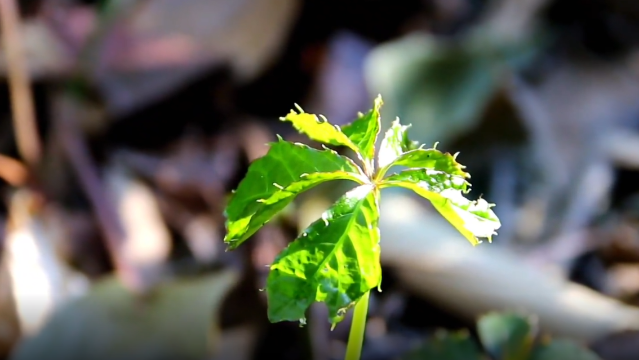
0,0,639,360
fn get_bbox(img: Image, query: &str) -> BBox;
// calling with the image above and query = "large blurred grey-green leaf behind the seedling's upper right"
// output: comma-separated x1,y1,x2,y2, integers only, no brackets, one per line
365,30,544,144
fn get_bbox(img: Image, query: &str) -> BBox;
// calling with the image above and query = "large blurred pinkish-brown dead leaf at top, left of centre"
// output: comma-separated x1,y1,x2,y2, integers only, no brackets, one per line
84,0,299,114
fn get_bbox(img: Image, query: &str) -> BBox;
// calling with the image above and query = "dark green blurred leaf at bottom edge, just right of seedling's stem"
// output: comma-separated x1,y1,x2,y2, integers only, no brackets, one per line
402,331,486,360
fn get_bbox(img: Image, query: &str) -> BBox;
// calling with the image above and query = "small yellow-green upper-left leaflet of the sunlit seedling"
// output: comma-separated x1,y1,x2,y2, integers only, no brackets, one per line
280,107,359,153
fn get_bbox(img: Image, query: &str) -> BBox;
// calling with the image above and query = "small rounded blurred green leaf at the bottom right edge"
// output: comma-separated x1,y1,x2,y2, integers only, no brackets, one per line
477,313,536,360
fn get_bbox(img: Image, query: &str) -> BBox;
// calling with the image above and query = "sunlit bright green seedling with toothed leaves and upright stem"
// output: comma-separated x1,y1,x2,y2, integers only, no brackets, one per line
224,96,500,360
